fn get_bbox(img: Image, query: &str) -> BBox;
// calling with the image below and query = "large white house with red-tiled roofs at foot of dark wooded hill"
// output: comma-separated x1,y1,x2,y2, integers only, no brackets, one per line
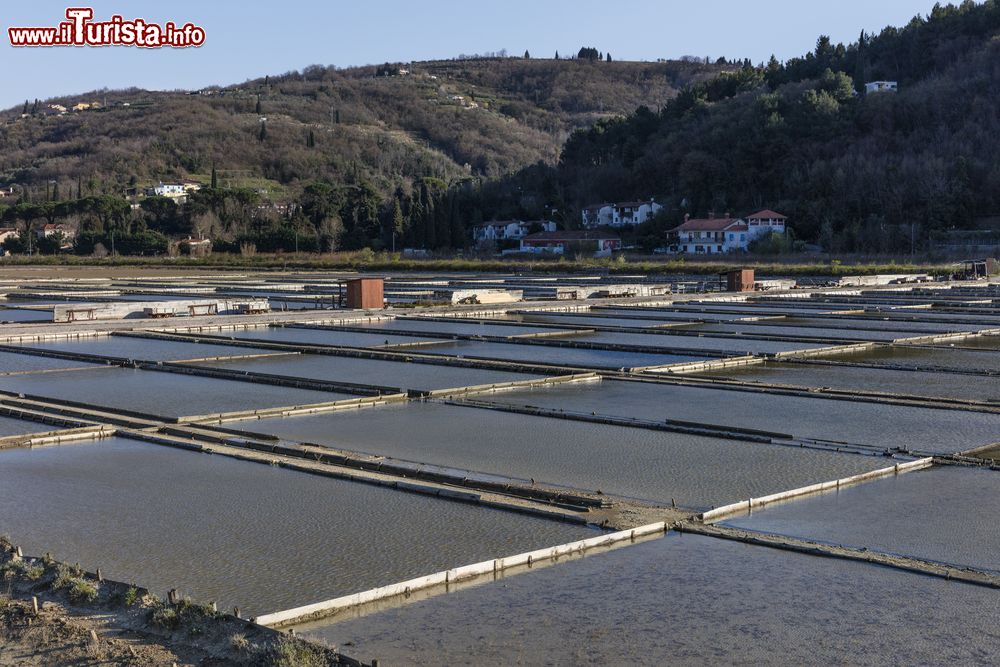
671,209,788,255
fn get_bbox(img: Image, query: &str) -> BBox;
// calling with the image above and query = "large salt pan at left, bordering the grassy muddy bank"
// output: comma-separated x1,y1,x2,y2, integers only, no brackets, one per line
0,439,596,614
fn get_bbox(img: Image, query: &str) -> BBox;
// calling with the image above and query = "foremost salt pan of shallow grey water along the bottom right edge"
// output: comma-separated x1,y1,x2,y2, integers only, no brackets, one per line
306,534,1000,666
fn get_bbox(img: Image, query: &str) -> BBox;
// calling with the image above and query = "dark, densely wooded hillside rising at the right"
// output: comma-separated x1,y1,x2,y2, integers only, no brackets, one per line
532,0,1000,251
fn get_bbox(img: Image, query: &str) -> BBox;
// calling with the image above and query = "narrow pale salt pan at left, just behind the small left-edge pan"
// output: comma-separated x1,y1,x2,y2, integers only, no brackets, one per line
23,336,269,361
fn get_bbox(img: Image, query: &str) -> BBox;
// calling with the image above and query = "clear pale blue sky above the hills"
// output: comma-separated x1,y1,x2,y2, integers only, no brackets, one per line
0,0,933,108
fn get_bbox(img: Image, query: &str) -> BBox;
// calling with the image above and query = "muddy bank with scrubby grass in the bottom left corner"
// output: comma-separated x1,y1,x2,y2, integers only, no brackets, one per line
0,538,360,667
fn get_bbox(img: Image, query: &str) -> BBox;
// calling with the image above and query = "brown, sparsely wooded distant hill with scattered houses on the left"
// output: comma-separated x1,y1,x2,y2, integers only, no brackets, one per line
0,58,716,198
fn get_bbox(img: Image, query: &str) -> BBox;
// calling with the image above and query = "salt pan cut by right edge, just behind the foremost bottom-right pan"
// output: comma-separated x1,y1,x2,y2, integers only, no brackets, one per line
725,467,1000,573
